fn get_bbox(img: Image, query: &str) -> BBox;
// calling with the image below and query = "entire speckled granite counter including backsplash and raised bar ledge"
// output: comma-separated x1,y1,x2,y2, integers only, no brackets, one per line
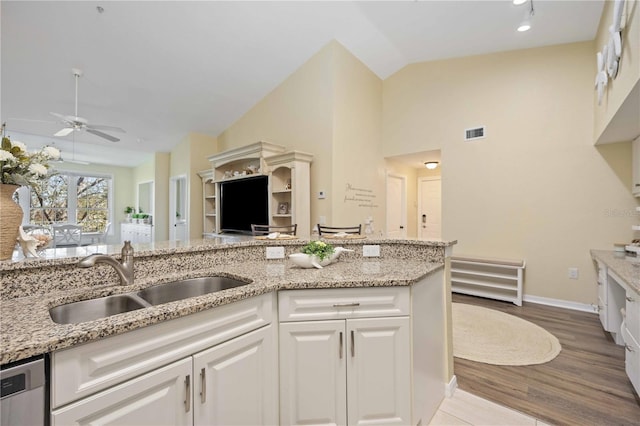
0,240,455,364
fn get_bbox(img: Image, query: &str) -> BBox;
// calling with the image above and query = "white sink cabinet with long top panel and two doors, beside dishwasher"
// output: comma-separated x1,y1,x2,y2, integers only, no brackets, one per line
51,294,278,425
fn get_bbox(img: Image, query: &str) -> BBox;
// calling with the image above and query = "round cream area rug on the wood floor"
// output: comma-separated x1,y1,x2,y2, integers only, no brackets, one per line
453,303,562,365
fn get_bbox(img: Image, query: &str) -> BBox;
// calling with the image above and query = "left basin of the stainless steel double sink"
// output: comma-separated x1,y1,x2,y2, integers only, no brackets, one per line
49,294,150,324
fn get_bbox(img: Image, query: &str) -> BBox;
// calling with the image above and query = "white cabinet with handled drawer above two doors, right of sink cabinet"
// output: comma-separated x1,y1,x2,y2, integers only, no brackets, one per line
279,287,412,425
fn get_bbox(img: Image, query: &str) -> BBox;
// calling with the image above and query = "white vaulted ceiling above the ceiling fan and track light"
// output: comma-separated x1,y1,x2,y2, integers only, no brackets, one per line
0,0,603,166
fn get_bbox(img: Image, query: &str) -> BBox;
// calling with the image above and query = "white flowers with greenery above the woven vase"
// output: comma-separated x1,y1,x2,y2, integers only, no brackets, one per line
0,136,60,186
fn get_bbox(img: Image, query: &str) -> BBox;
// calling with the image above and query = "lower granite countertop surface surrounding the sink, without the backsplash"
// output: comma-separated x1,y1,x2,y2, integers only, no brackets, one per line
0,255,447,364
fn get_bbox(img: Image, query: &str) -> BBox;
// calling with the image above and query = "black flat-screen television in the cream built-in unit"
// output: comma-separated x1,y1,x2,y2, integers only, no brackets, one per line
220,175,269,235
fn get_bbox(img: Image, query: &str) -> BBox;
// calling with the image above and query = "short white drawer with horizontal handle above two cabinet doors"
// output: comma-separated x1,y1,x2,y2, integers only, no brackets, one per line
278,286,411,322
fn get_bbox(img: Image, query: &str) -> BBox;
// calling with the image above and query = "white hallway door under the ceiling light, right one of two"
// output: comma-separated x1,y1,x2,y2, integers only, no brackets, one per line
418,178,442,240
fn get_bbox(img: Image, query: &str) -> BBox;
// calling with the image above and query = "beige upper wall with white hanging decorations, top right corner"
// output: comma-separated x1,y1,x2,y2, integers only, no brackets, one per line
590,0,640,140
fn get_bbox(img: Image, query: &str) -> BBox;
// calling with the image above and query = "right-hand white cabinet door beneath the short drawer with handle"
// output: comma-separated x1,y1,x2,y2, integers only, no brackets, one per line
346,317,411,425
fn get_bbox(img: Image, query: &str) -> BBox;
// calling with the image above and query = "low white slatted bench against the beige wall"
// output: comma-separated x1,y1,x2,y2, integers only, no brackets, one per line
451,255,525,306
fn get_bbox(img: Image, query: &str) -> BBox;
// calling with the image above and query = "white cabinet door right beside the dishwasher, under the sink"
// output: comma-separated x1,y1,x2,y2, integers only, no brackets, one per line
51,357,193,426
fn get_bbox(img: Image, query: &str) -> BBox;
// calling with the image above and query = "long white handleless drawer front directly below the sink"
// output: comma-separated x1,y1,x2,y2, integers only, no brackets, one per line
51,293,274,408
